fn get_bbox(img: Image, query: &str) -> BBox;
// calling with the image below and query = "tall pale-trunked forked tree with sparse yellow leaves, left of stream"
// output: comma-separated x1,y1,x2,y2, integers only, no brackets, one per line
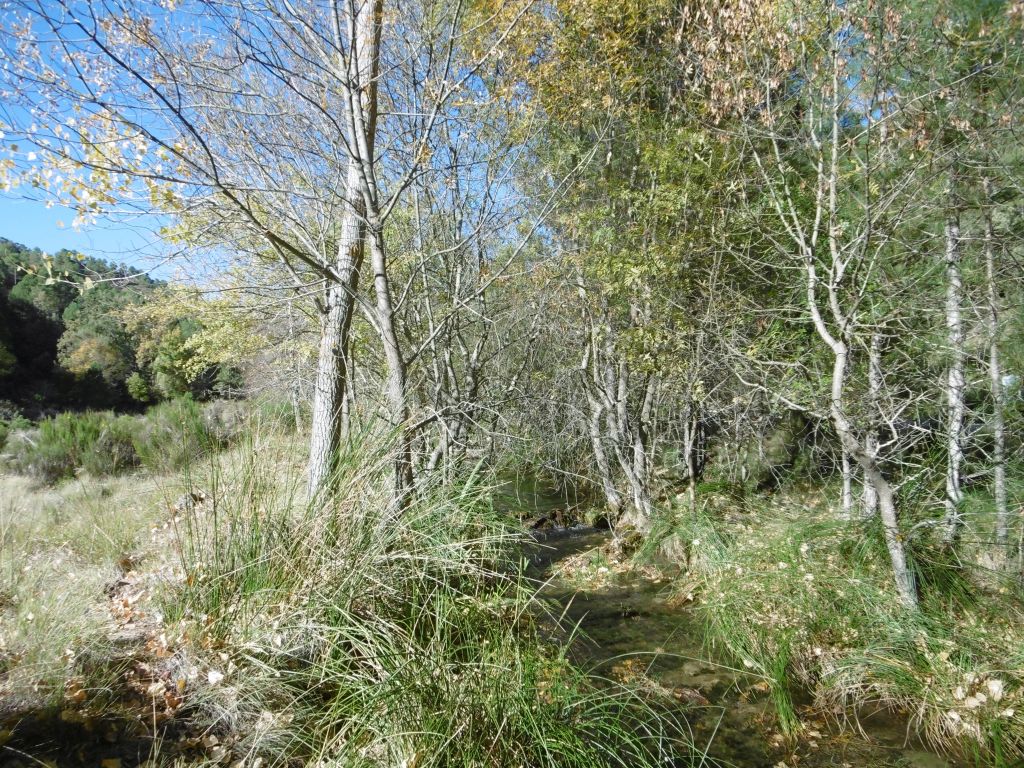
4,0,536,496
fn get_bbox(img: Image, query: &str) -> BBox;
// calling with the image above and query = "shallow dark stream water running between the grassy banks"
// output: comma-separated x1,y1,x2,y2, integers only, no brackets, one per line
529,528,958,768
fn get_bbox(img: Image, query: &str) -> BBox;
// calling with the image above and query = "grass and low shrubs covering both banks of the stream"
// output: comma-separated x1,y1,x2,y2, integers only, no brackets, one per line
0,401,1024,766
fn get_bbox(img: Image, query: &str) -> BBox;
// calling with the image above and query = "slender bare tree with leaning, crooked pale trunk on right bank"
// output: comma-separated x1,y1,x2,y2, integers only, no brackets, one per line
751,2,918,607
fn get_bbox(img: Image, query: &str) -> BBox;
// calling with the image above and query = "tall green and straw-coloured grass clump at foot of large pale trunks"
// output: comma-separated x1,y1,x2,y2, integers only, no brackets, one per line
165,436,696,766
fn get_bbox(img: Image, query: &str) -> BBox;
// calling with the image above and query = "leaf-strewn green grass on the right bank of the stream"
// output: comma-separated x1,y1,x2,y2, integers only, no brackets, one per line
643,488,1024,766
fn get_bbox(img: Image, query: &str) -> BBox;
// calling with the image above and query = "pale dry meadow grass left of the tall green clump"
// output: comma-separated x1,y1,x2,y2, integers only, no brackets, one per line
0,423,300,708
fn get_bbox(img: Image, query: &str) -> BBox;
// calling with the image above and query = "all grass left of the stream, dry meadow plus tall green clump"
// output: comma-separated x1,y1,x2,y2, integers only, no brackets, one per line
0,415,689,768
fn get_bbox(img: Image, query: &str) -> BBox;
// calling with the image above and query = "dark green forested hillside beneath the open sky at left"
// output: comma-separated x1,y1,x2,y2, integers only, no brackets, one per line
0,240,239,419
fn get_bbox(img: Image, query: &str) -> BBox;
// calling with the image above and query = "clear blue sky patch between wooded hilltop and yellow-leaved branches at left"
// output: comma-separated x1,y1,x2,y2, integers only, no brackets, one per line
0,193,172,279
